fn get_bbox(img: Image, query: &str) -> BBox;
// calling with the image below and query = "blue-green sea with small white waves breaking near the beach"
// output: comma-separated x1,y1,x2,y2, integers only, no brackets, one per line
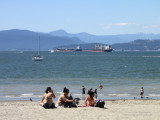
0,51,160,101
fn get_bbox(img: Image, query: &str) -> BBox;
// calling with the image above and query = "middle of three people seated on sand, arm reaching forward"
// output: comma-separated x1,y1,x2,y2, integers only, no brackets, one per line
56,87,74,107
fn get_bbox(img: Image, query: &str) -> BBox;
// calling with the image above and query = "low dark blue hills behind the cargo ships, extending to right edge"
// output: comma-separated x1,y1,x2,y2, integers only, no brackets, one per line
55,39,160,51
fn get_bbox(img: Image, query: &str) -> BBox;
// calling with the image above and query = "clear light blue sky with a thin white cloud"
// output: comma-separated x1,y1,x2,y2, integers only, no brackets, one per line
0,0,160,35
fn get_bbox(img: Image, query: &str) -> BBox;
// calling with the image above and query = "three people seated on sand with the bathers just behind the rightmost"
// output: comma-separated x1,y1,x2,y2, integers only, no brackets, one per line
40,84,103,108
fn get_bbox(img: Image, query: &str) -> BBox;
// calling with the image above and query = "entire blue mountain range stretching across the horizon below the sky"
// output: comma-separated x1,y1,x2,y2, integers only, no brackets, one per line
0,29,160,51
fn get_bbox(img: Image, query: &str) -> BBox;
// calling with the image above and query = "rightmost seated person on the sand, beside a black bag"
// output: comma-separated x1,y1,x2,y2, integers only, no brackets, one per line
82,91,96,107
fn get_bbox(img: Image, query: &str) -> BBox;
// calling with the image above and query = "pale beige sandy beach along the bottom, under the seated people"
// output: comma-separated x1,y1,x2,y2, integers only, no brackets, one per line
0,100,160,120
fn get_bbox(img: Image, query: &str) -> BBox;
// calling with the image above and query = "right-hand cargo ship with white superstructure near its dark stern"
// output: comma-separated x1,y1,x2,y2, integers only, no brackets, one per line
92,45,113,52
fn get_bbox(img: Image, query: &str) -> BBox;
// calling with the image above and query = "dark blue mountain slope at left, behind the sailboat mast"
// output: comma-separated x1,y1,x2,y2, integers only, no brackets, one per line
0,29,84,51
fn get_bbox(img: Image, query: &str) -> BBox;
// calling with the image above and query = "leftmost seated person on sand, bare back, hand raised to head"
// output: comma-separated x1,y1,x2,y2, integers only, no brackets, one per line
40,87,56,108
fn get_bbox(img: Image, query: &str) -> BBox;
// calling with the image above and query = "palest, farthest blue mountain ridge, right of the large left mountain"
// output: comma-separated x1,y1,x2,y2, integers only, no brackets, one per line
50,30,160,45
